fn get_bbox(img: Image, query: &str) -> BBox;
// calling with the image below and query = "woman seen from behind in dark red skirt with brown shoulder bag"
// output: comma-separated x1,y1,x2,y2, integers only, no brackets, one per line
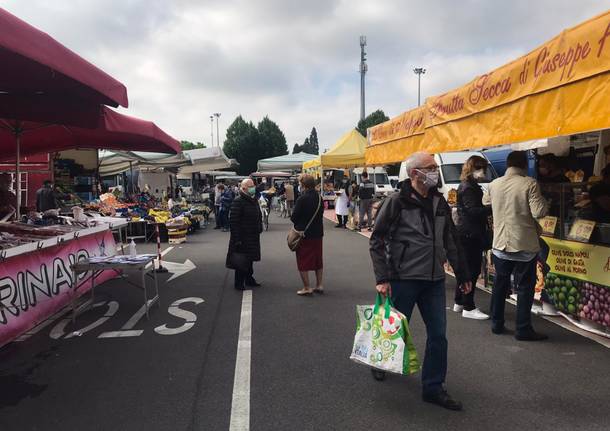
290,175,324,295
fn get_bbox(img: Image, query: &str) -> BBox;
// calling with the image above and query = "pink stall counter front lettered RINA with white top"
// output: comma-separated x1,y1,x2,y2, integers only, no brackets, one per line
0,223,116,346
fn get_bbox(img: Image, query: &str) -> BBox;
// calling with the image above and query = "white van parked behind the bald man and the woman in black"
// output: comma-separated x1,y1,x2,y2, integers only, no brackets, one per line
399,151,498,204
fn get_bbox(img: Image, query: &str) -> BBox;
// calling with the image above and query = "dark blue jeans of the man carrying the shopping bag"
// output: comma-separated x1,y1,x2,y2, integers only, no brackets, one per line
391,280,447,395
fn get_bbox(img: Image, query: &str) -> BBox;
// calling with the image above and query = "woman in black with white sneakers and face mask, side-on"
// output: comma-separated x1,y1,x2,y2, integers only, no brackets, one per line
453,156,491,320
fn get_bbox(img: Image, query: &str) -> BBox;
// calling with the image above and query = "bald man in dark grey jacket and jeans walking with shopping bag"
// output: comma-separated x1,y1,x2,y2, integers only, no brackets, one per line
370,153,472,410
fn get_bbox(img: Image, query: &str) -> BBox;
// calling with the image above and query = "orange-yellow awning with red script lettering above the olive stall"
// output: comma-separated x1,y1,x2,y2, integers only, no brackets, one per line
367,11,610,164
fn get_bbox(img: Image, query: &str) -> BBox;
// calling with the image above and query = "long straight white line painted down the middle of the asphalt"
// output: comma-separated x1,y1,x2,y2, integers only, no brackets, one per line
229,290,252,431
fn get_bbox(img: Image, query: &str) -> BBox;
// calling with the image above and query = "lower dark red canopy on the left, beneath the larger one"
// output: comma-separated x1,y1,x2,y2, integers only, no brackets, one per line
0,106,180,160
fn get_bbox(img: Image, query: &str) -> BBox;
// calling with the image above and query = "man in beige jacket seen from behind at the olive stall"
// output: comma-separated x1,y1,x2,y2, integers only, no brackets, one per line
489,151,549,341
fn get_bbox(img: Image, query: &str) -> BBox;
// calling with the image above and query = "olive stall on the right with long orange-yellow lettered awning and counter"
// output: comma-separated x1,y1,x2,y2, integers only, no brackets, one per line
366,8,610,335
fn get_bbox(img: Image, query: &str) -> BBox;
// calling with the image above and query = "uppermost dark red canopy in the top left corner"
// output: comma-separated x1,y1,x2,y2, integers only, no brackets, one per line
0,8,128,109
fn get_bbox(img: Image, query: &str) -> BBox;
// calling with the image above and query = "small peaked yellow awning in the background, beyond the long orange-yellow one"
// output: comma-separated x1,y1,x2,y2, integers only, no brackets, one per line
303,129,366,170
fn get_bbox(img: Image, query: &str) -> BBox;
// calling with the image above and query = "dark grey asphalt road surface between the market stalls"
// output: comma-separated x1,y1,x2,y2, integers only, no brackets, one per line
0,216,610,431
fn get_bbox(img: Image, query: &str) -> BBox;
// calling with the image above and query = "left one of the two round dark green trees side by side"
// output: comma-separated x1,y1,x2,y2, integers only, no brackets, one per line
223,115,261,175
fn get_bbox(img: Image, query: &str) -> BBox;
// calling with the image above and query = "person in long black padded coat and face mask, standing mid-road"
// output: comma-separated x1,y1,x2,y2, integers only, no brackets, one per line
226,179,263,290
